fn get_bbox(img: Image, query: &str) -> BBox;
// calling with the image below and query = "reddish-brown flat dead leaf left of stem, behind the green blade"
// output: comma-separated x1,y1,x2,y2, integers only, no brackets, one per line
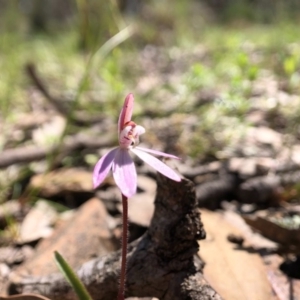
10,198,116,276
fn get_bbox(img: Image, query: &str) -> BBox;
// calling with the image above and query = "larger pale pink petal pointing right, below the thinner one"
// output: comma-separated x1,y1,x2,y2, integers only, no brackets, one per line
130,147,181,181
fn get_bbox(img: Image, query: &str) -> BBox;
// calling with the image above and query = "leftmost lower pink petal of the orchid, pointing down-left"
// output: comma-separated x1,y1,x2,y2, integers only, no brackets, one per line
93,148,118,188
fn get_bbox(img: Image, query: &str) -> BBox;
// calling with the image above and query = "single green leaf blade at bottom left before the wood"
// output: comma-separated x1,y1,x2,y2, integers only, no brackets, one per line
54,251,92,300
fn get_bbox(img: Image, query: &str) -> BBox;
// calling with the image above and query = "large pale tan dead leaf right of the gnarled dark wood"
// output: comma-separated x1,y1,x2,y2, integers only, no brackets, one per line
200,210,272,300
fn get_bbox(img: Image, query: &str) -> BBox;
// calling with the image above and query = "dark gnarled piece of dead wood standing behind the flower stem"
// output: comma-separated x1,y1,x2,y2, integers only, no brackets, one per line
10,175,221,300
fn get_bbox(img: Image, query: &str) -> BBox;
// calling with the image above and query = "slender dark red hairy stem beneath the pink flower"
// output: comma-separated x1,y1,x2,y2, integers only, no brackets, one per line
118,194,128,300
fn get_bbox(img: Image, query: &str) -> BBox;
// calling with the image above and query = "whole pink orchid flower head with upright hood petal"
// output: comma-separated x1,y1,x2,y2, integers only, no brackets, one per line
93,94,181,198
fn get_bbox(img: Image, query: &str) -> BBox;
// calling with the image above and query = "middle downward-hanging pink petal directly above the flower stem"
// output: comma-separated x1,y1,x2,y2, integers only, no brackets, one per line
113,148,137,198
